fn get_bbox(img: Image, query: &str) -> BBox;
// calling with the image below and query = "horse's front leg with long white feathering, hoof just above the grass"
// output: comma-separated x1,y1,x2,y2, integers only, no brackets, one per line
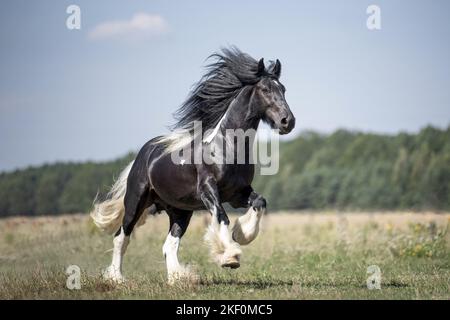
199,177,242,269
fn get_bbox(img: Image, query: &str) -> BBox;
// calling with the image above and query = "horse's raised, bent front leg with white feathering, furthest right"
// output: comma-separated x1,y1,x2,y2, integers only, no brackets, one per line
232,190,266,245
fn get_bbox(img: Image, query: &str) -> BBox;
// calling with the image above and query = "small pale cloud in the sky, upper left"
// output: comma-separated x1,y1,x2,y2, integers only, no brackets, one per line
88,12,169,40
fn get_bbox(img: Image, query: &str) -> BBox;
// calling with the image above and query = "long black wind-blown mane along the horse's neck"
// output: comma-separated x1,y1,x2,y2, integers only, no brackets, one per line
173,47,274,131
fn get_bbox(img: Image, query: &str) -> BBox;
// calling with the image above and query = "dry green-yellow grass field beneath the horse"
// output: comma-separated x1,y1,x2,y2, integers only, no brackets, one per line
0,212,450,299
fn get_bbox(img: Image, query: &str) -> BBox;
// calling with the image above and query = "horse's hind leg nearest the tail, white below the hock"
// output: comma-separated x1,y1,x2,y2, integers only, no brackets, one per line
103,184,150,283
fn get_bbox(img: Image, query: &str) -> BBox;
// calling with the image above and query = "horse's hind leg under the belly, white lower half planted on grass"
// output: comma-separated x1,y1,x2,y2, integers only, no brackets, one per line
163,208,198,284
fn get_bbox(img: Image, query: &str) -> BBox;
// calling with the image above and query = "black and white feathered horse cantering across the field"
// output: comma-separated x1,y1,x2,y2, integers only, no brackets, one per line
91,47,295,284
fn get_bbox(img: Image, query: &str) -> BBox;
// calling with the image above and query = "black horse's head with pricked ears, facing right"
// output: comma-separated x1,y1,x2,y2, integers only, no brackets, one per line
253,59,295,134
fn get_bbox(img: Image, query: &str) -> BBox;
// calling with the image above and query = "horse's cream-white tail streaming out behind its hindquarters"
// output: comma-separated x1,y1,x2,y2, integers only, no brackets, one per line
90,161,134,234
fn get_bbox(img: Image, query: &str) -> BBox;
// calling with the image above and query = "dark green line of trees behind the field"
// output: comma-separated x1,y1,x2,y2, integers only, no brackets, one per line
0,126,450,216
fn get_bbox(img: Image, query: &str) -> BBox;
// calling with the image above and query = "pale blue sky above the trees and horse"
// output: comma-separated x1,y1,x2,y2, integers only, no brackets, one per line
0,0,450,171
